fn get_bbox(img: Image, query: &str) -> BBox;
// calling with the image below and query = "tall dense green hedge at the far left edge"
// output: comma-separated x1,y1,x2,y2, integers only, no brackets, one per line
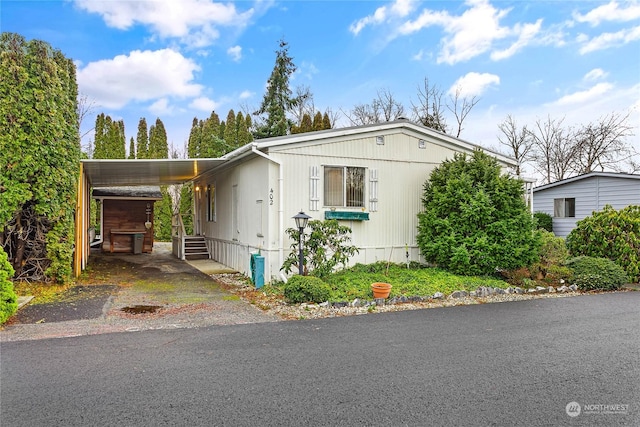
0,33,80,281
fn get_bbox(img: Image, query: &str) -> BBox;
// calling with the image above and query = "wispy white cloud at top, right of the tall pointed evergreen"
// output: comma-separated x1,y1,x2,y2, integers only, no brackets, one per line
397,0,542,65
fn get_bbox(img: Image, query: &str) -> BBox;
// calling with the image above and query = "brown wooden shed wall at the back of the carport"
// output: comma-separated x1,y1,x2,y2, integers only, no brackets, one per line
102,199,154,253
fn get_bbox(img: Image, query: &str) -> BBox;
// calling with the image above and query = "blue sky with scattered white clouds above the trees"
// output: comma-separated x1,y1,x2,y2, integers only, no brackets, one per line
0,0,640,174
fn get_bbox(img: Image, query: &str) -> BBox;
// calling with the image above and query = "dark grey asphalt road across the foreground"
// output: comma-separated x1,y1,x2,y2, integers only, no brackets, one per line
0,292,640,427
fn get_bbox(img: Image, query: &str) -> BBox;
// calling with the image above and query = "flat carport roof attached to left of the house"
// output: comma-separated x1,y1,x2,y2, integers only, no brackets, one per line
82,159,225,187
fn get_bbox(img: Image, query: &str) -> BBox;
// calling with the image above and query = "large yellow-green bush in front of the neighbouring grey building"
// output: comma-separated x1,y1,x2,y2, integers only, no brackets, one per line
567,205,640,282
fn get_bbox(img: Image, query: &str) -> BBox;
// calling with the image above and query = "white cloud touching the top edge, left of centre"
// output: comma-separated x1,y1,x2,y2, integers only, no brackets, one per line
75,0,255,47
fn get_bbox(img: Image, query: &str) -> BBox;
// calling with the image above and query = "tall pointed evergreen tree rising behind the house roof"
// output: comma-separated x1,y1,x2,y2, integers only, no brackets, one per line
254,40,298,138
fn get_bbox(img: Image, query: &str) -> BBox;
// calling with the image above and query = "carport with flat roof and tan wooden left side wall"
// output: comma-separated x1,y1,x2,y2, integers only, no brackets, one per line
73,158,225,276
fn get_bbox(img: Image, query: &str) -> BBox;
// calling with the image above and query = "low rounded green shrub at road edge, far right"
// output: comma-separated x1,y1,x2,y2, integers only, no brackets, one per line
566,256,628,291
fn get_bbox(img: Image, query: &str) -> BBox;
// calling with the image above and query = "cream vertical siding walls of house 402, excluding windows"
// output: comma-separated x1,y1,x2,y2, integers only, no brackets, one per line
196,125,516,281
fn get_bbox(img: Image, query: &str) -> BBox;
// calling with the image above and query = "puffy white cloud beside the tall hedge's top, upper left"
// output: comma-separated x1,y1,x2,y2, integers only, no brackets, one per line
77,49,202,109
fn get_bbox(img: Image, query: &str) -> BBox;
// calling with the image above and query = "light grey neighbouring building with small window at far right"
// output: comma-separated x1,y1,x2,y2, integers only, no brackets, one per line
533,172,640,237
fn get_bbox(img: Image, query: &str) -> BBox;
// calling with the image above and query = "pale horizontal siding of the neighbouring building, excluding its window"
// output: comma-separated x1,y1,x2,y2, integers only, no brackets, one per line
533,176,640,237
